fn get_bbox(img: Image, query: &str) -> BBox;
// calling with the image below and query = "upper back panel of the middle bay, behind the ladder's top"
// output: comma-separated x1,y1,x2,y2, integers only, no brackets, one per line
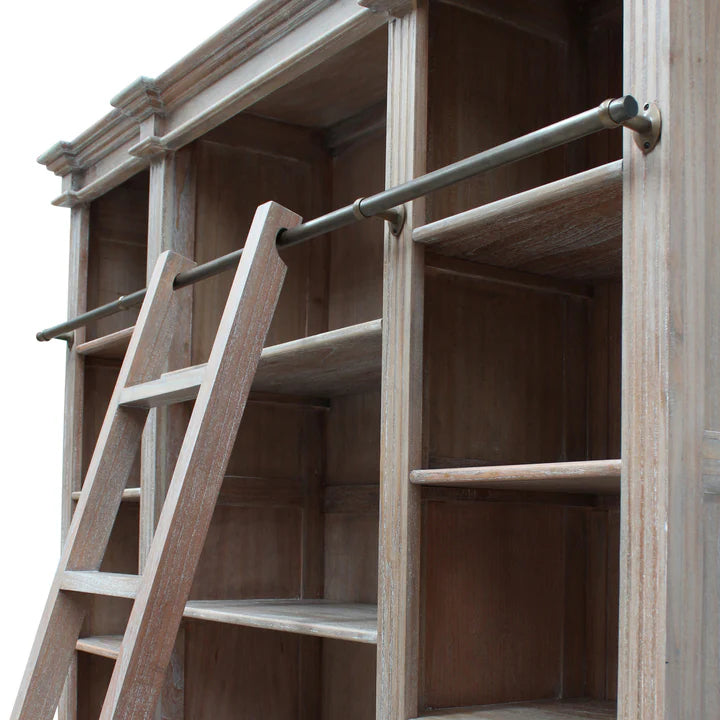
192,132,326,364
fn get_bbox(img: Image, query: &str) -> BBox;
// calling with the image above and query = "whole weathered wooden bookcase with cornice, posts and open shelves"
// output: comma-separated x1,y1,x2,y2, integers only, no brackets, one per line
22,0,720,720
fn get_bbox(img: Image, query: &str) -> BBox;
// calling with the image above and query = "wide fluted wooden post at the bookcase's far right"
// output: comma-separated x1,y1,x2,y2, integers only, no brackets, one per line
618,0,720,720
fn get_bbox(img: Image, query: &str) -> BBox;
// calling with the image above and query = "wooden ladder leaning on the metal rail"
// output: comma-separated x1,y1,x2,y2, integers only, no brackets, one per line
11,202,300,720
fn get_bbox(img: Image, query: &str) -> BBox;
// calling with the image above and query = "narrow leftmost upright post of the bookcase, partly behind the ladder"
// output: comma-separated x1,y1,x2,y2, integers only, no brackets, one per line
58,205,90,720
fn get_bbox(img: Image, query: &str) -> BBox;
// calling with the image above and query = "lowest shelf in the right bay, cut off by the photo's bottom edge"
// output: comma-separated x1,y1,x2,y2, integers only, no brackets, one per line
418,700,617,720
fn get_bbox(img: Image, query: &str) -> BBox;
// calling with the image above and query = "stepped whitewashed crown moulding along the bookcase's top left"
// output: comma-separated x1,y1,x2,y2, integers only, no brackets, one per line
39,0,386,207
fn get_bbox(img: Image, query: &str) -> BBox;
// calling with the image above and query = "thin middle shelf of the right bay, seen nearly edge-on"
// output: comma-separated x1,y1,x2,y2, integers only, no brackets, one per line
410,460,622,494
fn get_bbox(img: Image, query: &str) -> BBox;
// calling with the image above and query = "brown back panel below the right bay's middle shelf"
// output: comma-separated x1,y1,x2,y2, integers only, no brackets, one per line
420,500,587,712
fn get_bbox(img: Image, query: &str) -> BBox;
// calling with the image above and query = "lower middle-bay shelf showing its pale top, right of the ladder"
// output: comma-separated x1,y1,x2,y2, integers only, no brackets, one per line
184,599,377,644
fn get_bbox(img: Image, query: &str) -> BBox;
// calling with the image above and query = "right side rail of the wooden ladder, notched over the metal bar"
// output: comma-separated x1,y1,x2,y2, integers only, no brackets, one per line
100,202,300,720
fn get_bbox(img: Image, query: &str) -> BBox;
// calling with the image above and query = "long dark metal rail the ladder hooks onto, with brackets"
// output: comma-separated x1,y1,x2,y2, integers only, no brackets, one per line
36,95,659,341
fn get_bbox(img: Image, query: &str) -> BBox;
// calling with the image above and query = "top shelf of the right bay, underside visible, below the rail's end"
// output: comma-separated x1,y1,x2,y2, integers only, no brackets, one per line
413,160,622,280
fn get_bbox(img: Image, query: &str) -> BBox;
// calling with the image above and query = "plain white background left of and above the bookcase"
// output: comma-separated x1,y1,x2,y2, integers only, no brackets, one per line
0,0,251,718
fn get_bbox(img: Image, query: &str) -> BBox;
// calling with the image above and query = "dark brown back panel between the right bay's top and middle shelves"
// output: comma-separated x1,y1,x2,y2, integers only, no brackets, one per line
425,274,587,467
